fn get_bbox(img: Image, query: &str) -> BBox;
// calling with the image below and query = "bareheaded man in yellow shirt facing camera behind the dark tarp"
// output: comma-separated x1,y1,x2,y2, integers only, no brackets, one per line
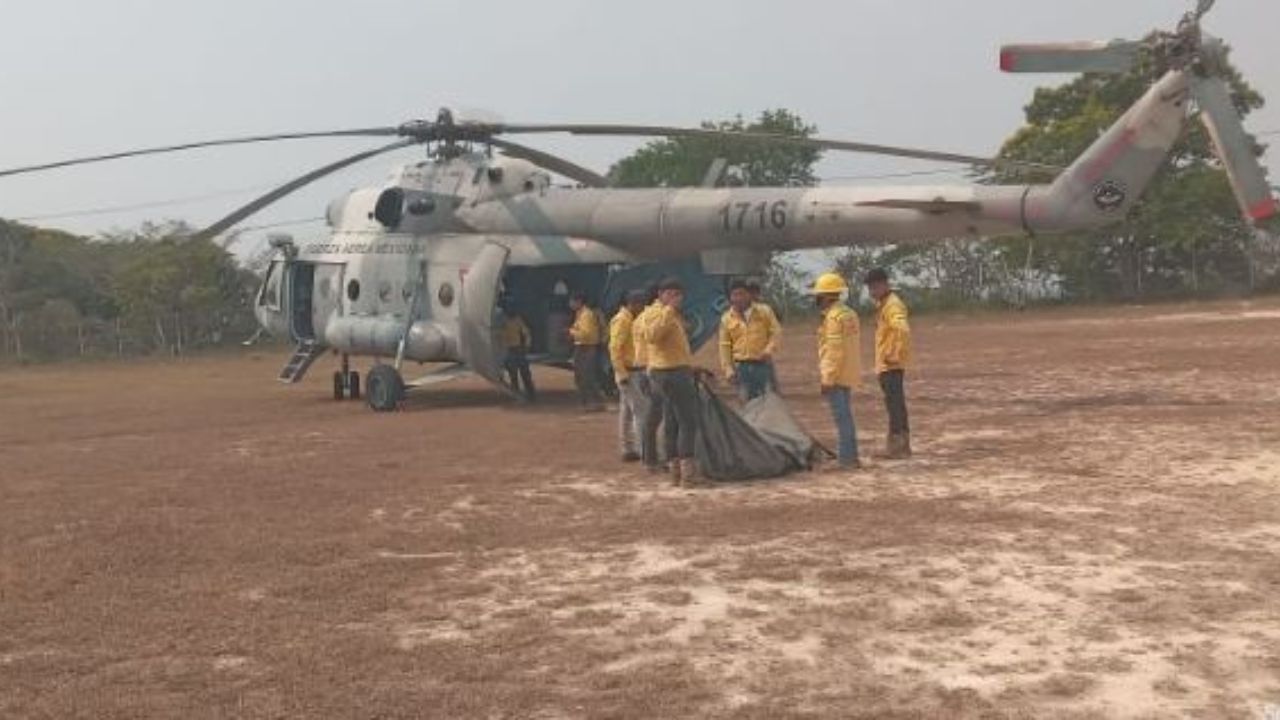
719,275,782,401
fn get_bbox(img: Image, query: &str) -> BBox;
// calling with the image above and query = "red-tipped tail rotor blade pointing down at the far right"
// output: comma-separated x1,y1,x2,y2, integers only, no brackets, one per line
1192,77,1280,223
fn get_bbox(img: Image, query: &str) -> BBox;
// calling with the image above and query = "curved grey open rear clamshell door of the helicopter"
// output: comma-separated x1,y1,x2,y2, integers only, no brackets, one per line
458,242,511,389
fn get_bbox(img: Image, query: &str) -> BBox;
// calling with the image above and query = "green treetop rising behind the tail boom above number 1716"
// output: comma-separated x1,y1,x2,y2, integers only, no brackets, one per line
609,109,820,187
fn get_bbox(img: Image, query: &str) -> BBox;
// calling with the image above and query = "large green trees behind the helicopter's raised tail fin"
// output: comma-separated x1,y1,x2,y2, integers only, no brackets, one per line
988,44,1263,300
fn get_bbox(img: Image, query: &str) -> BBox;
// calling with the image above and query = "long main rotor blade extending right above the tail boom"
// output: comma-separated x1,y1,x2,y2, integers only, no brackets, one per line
488,124,1062,172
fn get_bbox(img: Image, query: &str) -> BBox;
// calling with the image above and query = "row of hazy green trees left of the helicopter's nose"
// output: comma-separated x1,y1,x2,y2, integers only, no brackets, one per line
0,220,257,361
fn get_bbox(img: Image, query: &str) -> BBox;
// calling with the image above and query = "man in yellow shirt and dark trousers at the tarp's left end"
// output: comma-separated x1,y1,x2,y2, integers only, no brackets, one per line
643,278,698,486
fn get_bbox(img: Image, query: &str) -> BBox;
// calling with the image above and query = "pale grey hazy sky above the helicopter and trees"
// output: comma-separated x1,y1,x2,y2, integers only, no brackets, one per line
0,0,1280,249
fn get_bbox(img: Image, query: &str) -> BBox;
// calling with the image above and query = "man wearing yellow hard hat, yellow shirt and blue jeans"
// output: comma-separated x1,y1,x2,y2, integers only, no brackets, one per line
813,273,861,469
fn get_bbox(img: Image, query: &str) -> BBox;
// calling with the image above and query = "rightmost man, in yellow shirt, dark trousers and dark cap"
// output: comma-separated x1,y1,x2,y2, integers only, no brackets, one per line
867,268,911,459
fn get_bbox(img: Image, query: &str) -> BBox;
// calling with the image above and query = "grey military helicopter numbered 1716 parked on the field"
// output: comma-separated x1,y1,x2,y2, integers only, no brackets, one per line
0,0,1280,411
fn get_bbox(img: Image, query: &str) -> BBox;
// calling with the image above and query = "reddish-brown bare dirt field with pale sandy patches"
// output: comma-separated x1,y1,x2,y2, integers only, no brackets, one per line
0,302,1280,719
